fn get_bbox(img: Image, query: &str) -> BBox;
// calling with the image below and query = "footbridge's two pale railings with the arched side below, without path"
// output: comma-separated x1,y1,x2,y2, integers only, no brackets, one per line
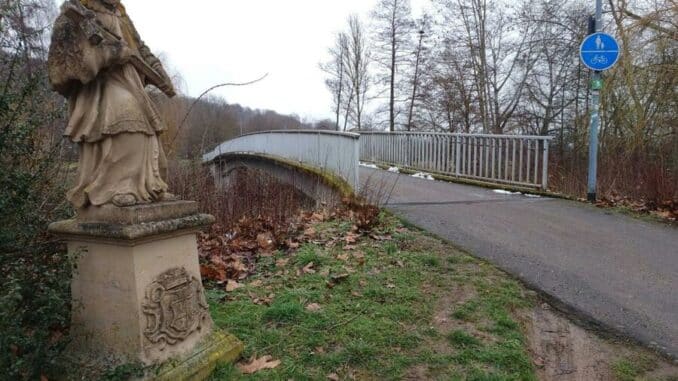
203,130,551,199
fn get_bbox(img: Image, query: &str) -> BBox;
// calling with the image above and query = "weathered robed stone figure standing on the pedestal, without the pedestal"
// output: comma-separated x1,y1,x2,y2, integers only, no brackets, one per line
48,0,174,208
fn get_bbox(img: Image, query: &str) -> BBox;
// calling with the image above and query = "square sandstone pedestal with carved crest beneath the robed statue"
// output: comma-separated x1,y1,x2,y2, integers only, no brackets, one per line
50,201,242,380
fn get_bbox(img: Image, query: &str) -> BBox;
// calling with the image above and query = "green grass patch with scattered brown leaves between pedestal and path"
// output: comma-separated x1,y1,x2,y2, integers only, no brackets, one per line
208,215,535,380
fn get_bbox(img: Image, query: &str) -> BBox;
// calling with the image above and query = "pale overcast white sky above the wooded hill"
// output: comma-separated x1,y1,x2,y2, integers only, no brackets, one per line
57,0,427,119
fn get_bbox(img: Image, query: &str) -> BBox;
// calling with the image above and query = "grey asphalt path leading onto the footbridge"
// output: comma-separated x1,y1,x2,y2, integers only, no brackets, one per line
360,168,678,359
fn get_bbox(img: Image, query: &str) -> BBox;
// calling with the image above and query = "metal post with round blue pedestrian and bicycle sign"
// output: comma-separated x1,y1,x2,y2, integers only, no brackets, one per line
579,0,619,202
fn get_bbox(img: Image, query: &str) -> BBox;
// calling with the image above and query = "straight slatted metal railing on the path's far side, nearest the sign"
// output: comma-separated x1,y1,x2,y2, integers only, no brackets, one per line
360,132,552,190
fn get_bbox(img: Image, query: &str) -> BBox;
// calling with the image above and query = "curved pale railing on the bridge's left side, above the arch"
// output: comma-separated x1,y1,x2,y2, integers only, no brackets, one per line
203,130,360,190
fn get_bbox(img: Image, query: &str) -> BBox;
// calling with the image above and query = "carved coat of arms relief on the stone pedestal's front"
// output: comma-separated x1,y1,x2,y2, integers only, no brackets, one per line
143,268,209,346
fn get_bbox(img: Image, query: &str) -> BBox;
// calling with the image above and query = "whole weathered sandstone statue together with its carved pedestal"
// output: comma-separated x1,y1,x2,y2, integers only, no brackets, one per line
48,0,243,372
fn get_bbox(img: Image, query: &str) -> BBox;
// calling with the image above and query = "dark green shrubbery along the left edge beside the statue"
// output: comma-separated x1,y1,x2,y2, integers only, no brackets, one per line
0,0,70,380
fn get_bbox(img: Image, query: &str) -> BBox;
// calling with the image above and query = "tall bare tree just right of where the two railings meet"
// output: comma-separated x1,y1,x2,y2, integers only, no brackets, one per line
371,0,413,131
